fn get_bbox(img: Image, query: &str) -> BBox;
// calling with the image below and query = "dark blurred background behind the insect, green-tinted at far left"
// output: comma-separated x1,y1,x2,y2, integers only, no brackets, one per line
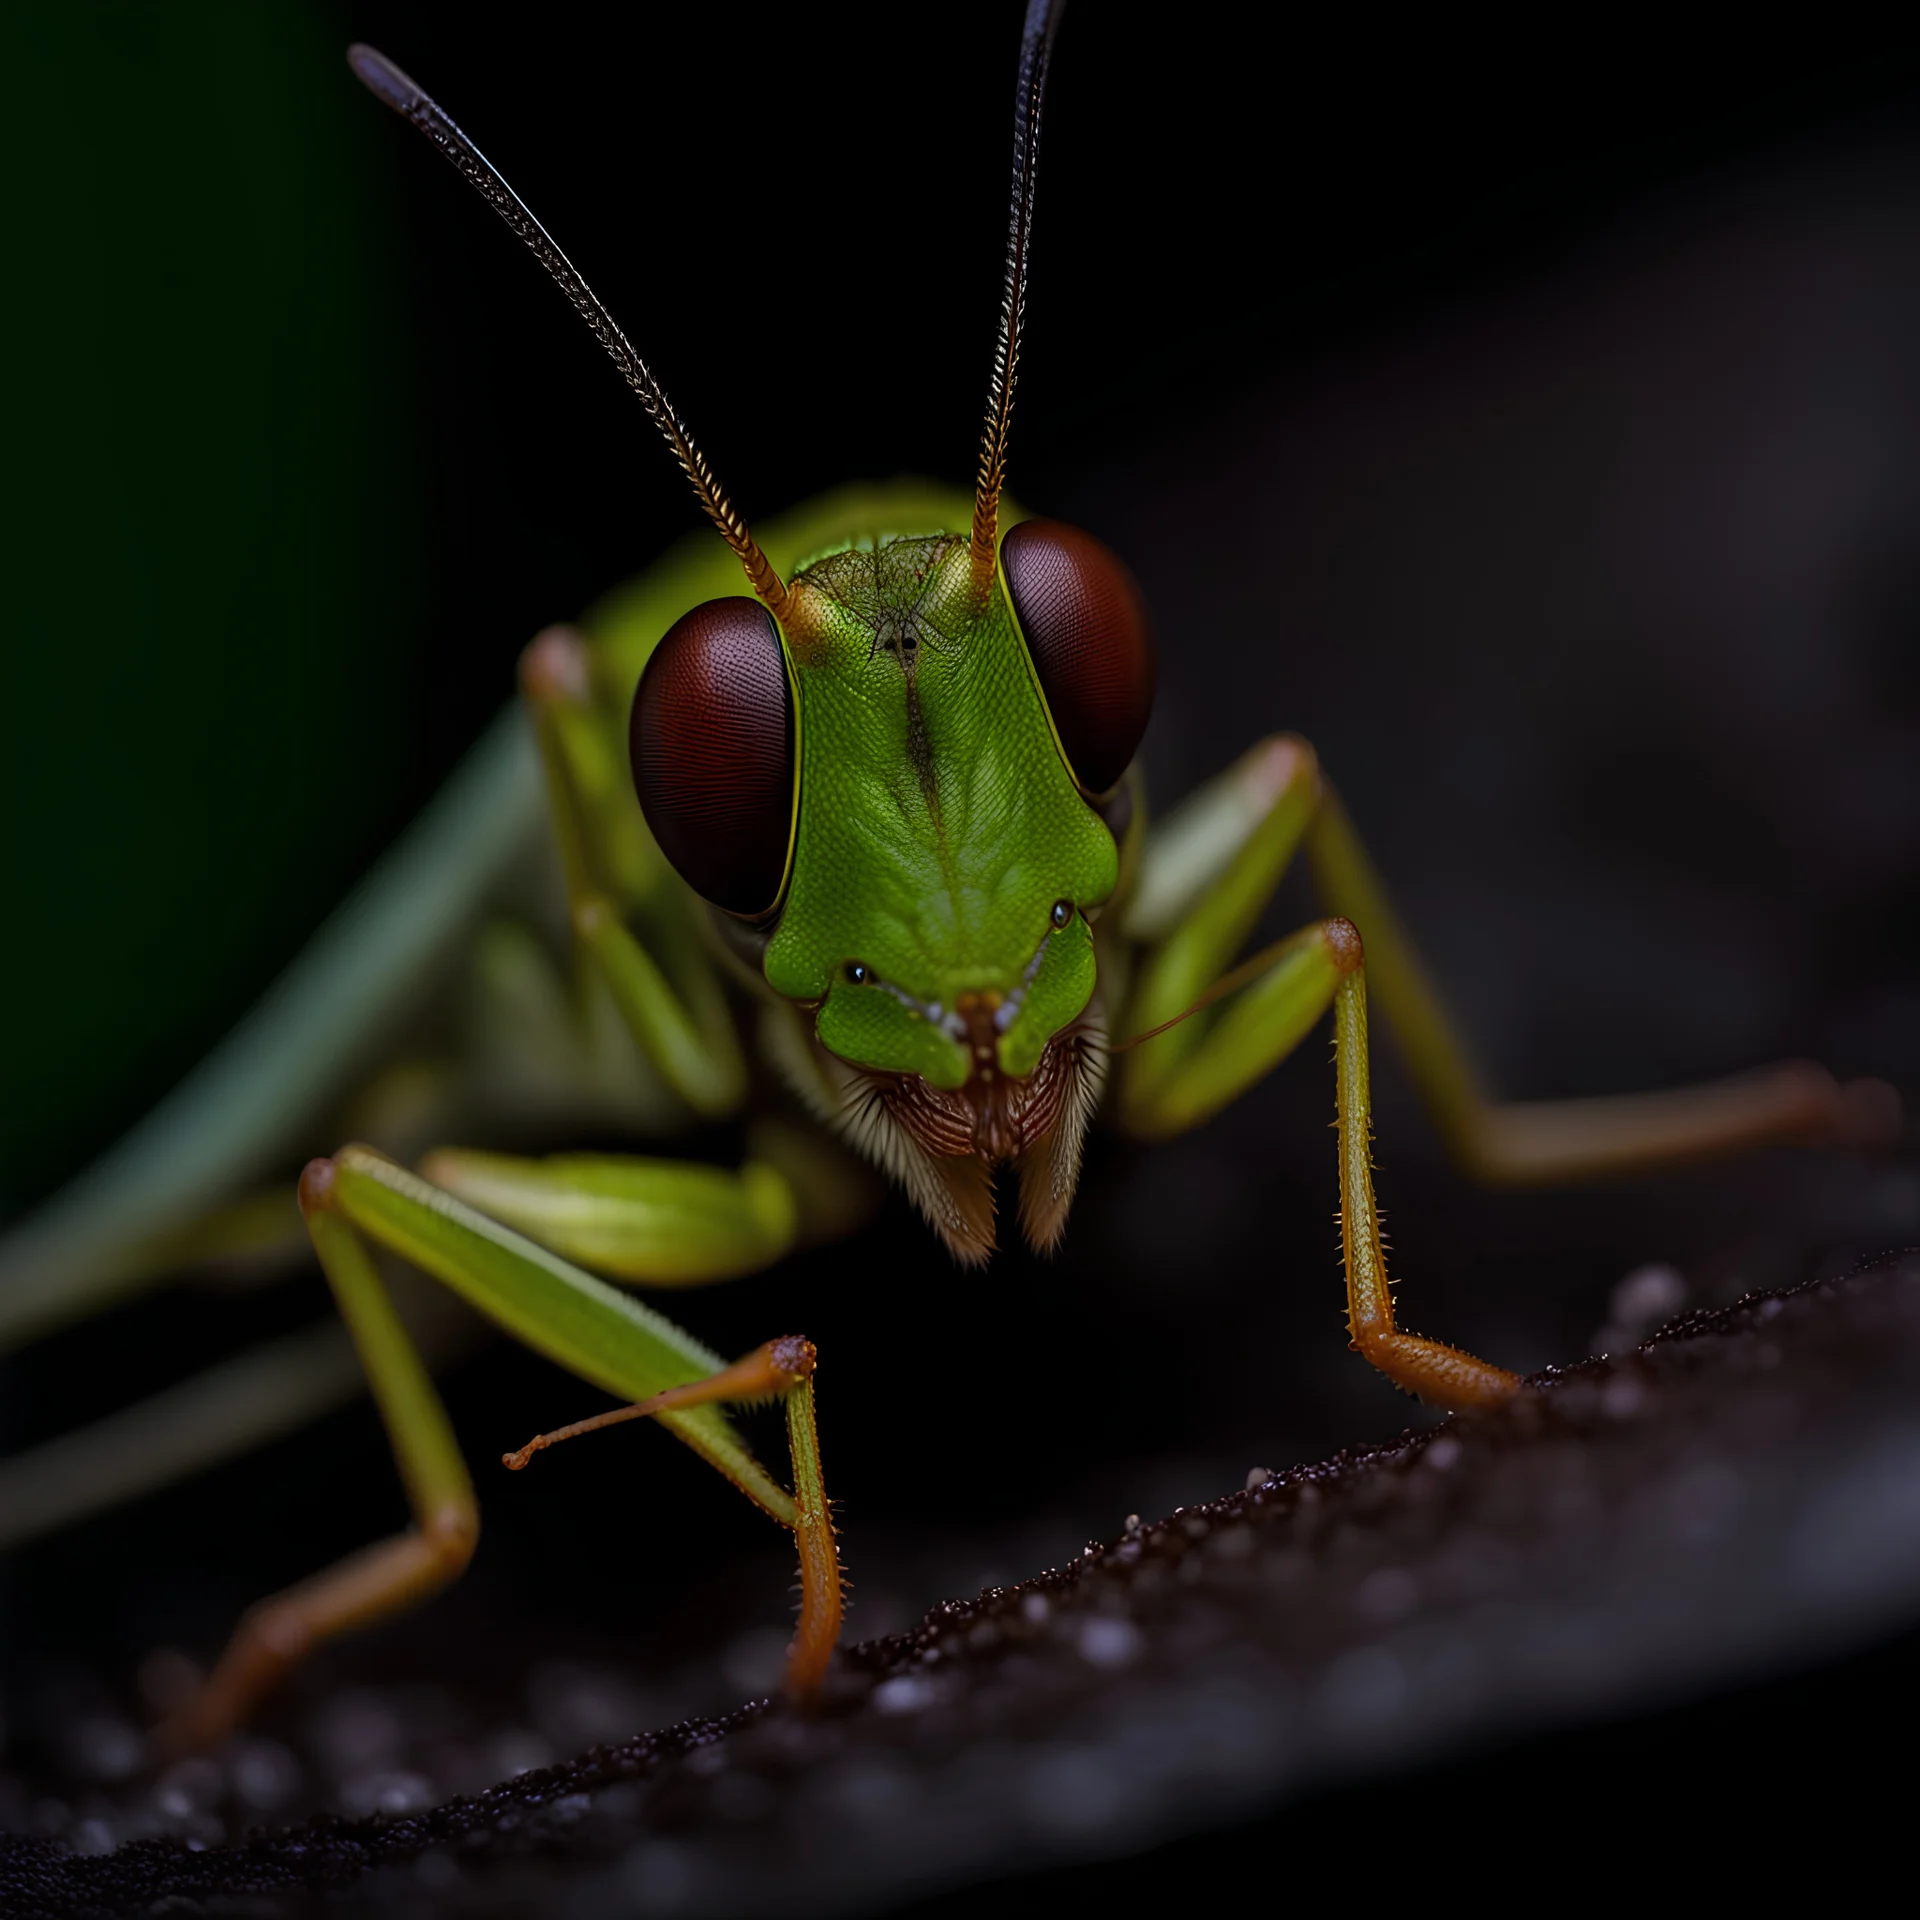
0,4,1920,1896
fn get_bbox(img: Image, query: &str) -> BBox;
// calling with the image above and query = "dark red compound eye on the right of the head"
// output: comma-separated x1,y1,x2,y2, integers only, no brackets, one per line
1000,520,1154,793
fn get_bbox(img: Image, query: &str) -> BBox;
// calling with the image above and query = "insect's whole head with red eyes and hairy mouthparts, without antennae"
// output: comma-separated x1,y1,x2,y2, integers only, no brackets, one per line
630,522,1121,1256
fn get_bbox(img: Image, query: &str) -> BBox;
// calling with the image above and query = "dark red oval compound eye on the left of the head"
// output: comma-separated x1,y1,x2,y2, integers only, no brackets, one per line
628,597,793,916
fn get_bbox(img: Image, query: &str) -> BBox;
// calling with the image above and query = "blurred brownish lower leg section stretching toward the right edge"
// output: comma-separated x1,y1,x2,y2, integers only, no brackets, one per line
1306,785,1899,1183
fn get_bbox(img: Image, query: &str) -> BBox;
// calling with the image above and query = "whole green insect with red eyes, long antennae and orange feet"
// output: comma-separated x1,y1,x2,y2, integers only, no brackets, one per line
0,0,1889,1745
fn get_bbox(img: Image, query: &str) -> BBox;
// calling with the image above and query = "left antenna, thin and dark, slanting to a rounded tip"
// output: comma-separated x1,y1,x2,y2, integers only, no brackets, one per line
348,44,787,618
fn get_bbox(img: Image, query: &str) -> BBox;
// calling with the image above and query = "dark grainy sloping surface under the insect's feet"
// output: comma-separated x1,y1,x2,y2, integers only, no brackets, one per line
11,1254,1920,1914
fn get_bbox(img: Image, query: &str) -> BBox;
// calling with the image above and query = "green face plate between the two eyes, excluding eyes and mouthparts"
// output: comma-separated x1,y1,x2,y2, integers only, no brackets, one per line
766,534,1117,1087
